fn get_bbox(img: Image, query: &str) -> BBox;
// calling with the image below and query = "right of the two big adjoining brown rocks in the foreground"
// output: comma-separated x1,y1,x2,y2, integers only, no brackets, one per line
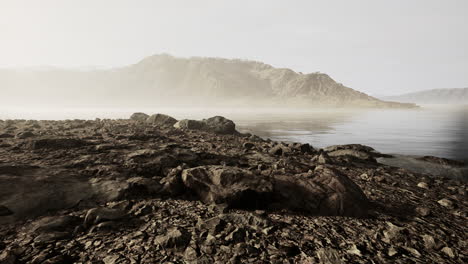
274,168,369,217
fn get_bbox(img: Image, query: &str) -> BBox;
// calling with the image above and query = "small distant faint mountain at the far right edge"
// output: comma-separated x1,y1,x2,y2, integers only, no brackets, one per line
382,88,468,104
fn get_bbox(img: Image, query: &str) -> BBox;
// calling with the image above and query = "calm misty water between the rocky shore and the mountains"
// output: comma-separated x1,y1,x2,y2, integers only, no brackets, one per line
0,107,468,159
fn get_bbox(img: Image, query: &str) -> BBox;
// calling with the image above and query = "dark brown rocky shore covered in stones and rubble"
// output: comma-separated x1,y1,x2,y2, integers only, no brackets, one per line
0,113,468,264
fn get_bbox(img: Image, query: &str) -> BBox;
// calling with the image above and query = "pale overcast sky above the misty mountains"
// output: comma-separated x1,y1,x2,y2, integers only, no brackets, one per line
0,0,468,95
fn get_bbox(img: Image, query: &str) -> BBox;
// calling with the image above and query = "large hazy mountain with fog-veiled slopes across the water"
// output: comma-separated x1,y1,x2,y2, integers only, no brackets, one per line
0,54,415,108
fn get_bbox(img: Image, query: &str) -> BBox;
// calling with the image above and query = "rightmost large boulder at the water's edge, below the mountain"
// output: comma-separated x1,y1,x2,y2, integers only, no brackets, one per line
174,116,239,135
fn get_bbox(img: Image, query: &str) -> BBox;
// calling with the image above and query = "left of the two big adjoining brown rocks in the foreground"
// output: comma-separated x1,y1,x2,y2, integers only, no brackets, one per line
182,166,273,208
